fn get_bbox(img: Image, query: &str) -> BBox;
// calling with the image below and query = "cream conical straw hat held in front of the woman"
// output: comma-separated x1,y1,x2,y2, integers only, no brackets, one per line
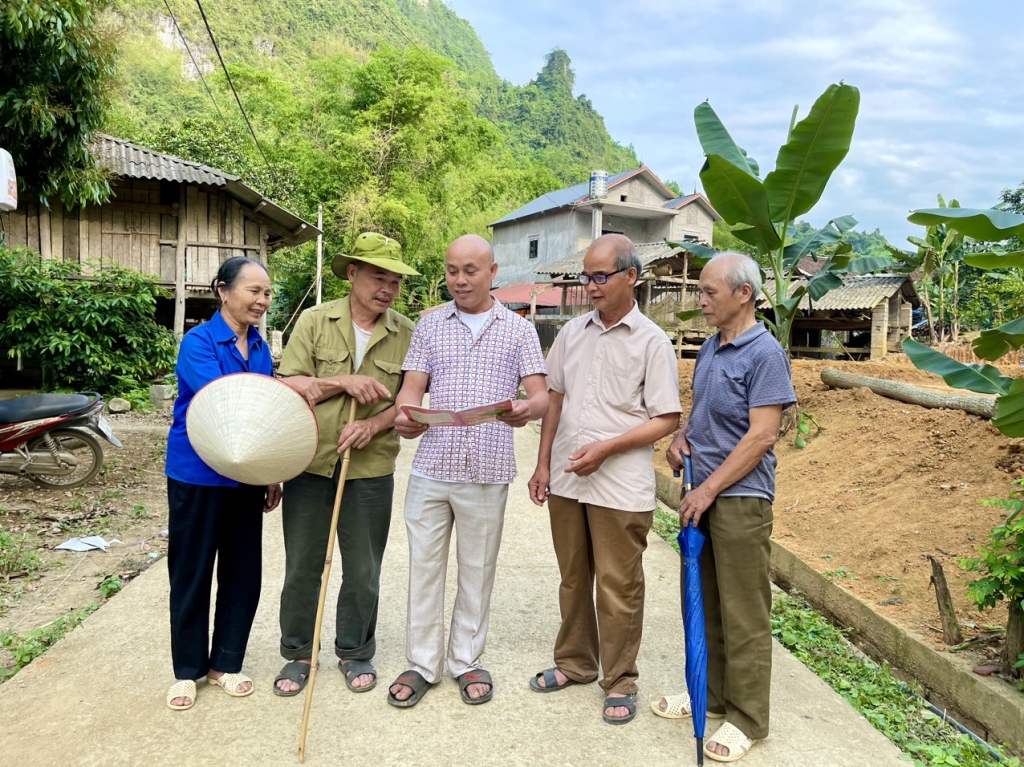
185,373,319,485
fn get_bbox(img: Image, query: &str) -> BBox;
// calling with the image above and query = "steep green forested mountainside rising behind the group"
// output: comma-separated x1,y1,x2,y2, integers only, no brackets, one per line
105,0,638,314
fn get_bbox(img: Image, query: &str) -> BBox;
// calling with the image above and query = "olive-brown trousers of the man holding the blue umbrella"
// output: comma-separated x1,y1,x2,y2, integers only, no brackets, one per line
696,498,774,738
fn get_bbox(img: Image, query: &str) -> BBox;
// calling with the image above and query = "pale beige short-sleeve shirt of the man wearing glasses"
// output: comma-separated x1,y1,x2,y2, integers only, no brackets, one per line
548,303,682,511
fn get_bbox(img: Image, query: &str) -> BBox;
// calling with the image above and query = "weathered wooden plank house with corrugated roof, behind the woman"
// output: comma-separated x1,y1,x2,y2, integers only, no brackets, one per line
0,134,319,338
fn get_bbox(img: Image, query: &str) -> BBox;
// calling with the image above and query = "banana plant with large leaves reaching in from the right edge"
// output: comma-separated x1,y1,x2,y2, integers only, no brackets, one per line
903,208,1024,437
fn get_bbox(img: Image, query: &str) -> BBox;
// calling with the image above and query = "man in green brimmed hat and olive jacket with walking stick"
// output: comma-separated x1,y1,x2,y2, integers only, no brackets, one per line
273,232,418,696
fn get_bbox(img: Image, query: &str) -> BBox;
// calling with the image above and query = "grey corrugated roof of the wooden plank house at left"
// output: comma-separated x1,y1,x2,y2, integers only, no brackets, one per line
92,133,319,249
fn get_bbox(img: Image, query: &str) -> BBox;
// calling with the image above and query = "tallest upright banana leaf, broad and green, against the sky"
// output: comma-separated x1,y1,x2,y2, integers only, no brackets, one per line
765,84,860,221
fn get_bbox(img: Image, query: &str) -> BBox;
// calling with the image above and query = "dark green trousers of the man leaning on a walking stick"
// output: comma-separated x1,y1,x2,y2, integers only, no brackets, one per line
281,469,394,661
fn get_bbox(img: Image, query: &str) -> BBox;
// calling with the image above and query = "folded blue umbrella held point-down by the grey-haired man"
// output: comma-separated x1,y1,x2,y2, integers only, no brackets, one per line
675,456,708,765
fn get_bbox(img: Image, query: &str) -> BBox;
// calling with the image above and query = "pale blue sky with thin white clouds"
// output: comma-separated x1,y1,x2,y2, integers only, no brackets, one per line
447,0,1024,247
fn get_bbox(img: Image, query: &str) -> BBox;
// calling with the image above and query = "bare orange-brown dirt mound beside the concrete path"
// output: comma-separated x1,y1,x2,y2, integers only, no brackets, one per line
655,357,1024,655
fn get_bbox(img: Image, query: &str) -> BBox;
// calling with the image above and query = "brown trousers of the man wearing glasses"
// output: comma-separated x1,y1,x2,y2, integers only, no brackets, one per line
548,496,654,694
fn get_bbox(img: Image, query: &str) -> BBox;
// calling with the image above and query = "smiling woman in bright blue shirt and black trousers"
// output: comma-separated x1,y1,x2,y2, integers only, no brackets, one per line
166,258,281,711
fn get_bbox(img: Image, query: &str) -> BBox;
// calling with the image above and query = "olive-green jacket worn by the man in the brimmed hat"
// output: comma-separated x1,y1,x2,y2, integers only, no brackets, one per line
278,296,416,479
